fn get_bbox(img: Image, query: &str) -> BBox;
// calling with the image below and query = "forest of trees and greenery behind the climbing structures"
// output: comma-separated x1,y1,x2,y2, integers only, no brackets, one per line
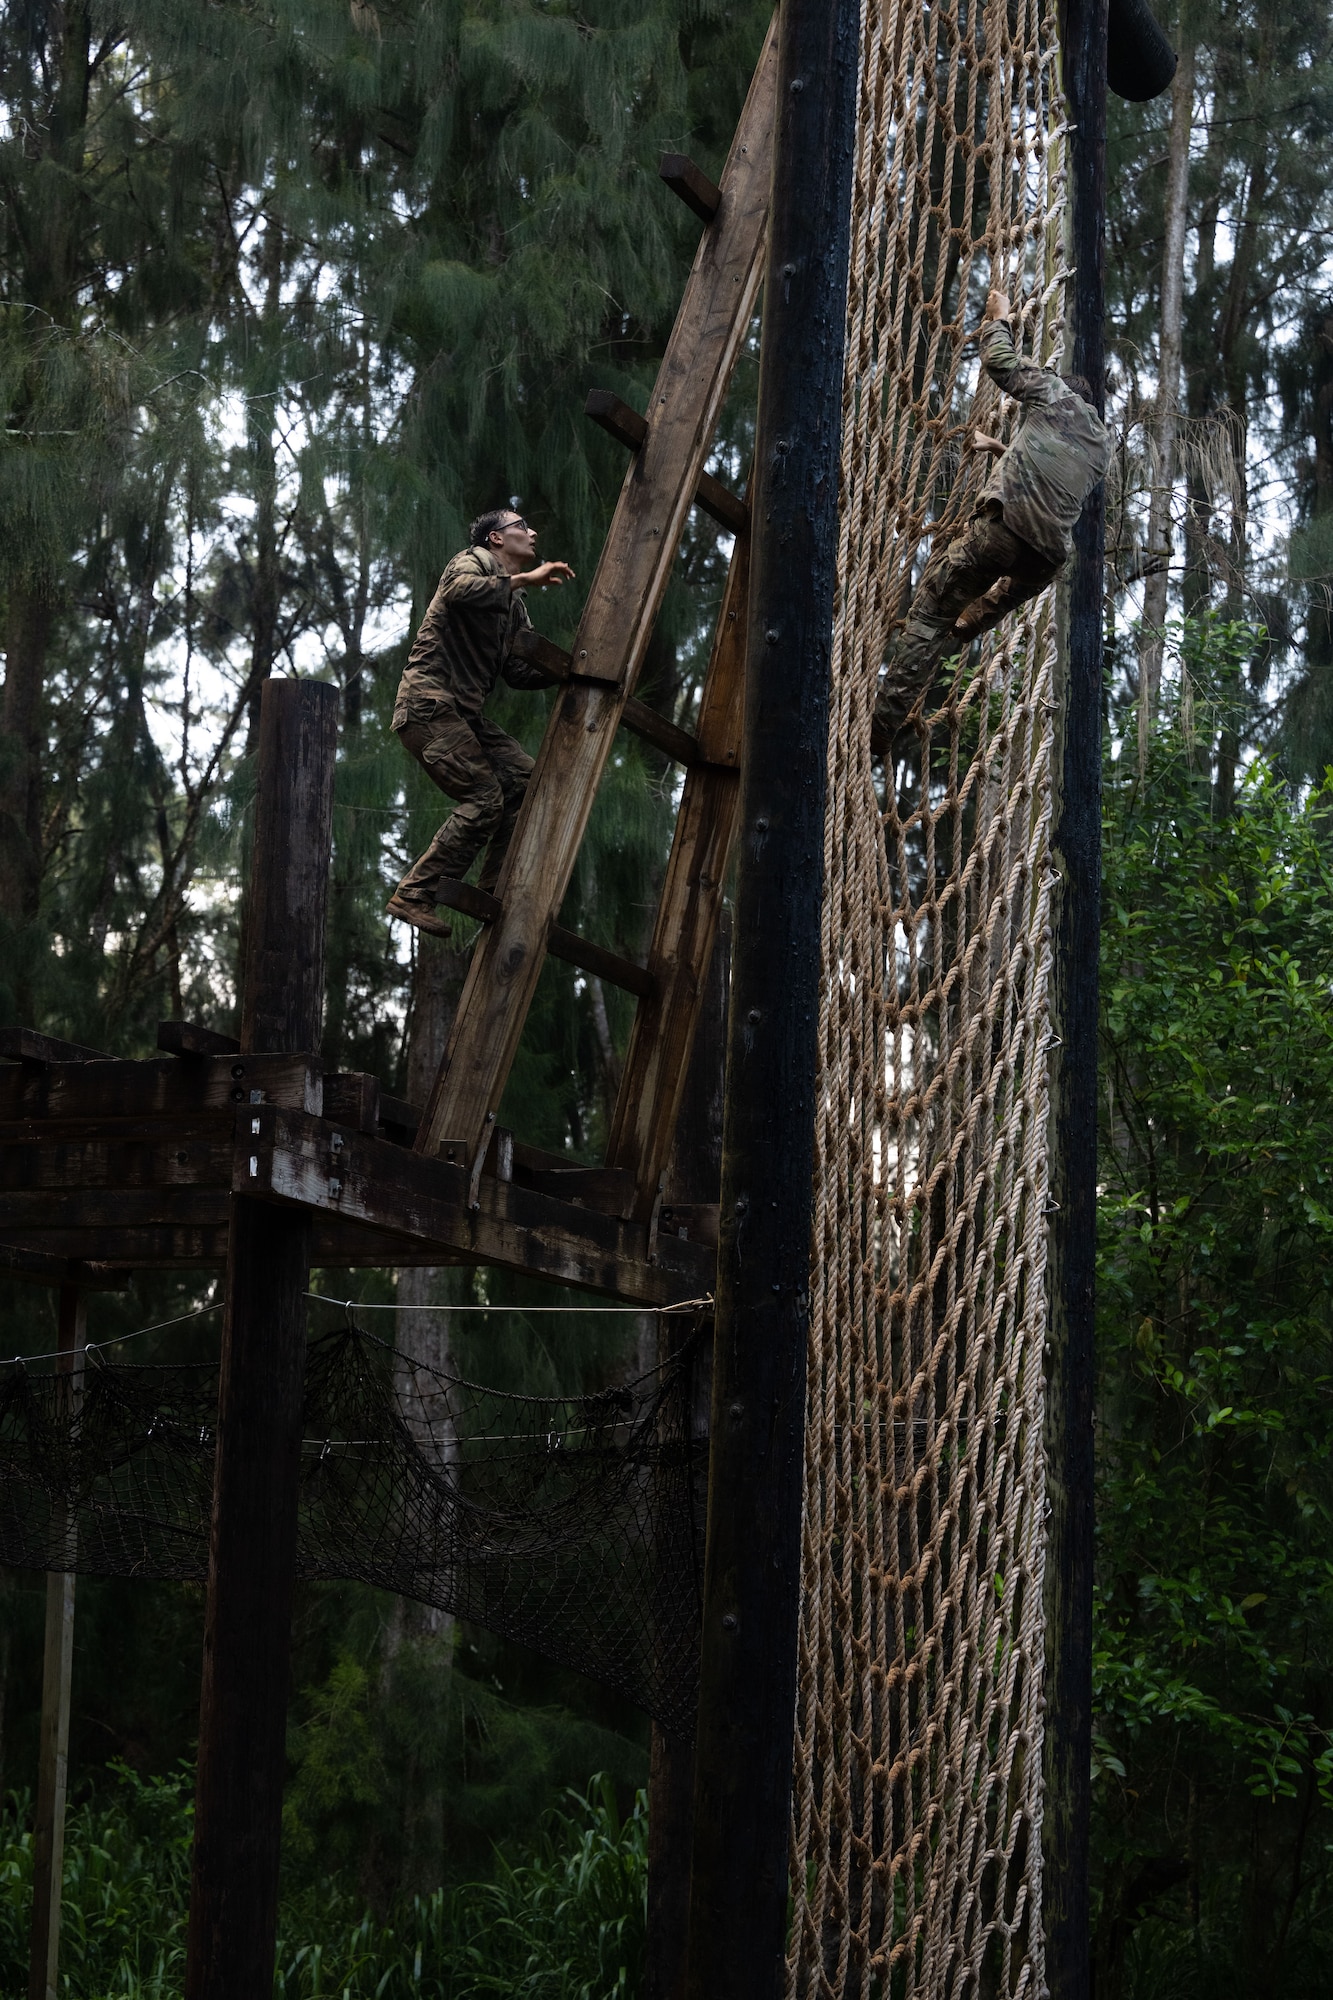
0,0,1333,2000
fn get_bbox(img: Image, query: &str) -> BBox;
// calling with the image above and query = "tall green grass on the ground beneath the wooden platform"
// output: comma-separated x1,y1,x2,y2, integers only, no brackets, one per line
0,1766,648,2000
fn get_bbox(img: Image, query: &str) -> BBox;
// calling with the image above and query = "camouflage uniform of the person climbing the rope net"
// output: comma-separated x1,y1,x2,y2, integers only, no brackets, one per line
875,320,1111,740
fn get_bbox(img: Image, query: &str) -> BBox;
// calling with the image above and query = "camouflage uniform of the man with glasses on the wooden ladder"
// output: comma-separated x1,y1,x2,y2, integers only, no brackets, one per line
394,548,550,908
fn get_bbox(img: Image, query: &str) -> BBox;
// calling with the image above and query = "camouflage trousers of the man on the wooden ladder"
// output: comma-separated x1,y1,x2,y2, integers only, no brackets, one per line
396,708,532,902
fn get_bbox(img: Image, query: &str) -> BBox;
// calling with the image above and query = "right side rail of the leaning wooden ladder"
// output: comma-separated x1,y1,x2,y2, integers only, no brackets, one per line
606,536,751,1222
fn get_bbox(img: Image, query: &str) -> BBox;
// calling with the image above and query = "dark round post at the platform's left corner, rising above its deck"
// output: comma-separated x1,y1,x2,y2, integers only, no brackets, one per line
186,680,338,2000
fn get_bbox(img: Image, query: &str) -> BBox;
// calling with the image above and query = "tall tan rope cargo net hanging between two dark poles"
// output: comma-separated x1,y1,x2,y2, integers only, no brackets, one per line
787,0,1067,2000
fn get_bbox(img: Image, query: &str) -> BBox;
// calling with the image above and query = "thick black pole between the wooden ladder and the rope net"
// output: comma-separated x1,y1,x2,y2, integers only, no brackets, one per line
687,0,861,2000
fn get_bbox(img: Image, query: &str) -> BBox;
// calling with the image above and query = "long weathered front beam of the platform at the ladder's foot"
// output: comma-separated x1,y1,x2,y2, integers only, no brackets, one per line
236,1108,713,1306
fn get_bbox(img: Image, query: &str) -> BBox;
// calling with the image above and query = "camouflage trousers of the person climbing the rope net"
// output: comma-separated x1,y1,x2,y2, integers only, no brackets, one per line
875,500,1063,736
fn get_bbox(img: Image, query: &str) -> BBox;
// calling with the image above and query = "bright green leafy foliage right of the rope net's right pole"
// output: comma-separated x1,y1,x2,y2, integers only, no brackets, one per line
1097,672,1333,1992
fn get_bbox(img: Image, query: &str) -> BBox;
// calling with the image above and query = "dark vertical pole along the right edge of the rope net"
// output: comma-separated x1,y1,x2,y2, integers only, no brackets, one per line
1043,0,1107,2000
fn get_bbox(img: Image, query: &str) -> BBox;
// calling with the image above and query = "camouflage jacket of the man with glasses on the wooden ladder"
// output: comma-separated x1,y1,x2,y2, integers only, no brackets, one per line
392,548,550,730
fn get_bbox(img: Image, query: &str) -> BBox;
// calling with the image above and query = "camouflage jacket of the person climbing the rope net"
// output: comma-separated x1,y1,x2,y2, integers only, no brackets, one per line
981,320,1111,562
